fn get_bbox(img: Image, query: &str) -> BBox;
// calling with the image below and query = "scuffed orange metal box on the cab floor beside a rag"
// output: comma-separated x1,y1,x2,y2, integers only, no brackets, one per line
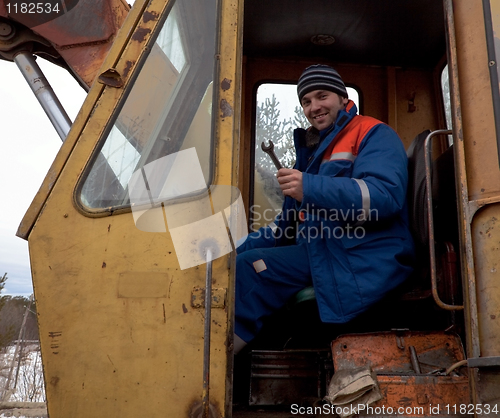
332,331,470,416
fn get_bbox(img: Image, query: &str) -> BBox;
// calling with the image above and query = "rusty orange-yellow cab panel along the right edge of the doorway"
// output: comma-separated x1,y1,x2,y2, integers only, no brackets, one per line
452,0,500,406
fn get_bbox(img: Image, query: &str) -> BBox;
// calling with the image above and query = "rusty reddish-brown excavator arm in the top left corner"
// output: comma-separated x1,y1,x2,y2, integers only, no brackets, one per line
0,0,130,90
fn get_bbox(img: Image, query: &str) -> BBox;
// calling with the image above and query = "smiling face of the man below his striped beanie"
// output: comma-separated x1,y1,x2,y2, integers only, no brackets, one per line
300,90,348,131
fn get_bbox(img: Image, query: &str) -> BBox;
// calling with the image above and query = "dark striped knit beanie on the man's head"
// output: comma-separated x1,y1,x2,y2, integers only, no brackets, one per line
297,64,348,101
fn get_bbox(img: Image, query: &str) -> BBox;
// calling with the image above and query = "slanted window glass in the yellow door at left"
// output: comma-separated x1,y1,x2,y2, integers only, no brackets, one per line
80,0,216,209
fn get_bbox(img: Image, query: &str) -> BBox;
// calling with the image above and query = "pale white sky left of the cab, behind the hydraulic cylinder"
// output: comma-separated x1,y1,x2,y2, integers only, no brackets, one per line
0,58,86,297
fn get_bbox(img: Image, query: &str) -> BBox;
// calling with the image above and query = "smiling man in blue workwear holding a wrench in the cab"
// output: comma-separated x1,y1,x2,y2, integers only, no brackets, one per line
235,65,414,352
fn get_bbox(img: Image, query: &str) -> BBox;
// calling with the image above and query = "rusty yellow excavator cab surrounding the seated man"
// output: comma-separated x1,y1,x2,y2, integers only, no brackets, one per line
0,0,500,418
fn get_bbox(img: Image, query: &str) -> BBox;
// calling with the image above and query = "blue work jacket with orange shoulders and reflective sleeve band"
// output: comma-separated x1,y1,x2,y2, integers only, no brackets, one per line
242,101,414,323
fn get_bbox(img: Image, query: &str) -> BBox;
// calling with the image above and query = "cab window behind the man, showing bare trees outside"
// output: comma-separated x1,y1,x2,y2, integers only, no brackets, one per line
250,83,360,230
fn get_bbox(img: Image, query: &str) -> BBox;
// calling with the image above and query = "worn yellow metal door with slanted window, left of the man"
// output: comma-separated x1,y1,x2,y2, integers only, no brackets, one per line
18,0,245,418
